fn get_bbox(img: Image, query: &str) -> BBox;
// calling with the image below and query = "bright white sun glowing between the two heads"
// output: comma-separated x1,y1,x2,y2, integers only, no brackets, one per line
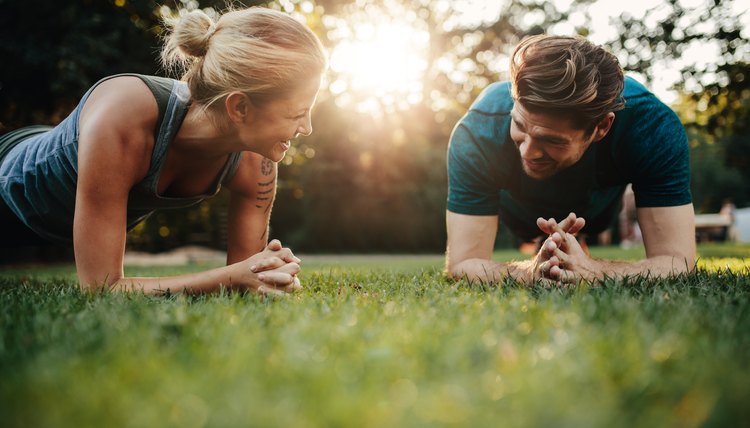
327,6,430,113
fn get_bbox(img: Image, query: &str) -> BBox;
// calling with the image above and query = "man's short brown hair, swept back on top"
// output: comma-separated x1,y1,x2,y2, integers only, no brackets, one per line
510,35,625,134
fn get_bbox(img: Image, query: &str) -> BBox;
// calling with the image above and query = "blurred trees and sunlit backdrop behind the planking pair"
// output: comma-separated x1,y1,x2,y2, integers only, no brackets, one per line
0,0,750,253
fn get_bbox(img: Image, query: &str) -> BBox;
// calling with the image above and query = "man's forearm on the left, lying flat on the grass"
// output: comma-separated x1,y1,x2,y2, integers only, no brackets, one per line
448,259,533,283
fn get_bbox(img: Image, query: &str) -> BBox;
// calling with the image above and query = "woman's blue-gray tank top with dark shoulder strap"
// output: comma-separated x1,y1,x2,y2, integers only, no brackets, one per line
0,74,242,244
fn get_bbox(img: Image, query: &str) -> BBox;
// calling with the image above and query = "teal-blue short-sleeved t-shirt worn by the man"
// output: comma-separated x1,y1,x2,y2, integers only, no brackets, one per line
448,77,692,238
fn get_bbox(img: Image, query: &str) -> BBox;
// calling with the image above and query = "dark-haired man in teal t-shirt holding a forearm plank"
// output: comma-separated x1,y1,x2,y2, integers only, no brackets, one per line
446,35,695,282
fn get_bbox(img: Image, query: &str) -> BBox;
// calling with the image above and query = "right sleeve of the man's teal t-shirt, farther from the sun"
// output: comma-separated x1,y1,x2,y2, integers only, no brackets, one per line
629,96,692,207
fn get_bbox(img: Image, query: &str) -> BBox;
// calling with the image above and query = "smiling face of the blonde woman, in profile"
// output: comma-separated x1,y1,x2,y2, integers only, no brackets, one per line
241,79,320,162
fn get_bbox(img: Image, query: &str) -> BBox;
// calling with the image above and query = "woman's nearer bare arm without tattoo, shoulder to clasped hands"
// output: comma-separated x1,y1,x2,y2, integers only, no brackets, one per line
73,77,299,294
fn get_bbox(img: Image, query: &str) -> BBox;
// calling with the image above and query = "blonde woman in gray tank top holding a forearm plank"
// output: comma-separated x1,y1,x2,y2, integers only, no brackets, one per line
0,8,327,294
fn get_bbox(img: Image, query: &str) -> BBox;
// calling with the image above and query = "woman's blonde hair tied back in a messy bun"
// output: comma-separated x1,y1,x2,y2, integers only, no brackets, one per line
162,7,327,109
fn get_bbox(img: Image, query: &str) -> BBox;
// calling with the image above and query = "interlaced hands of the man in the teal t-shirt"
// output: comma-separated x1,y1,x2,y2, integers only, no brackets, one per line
532,213,596,283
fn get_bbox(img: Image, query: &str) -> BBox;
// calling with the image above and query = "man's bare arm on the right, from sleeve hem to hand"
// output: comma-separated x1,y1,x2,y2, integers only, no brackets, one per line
541,204,695,282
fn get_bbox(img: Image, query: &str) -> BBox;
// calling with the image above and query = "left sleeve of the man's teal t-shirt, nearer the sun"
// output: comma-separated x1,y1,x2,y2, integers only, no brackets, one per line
447,112,501,215
